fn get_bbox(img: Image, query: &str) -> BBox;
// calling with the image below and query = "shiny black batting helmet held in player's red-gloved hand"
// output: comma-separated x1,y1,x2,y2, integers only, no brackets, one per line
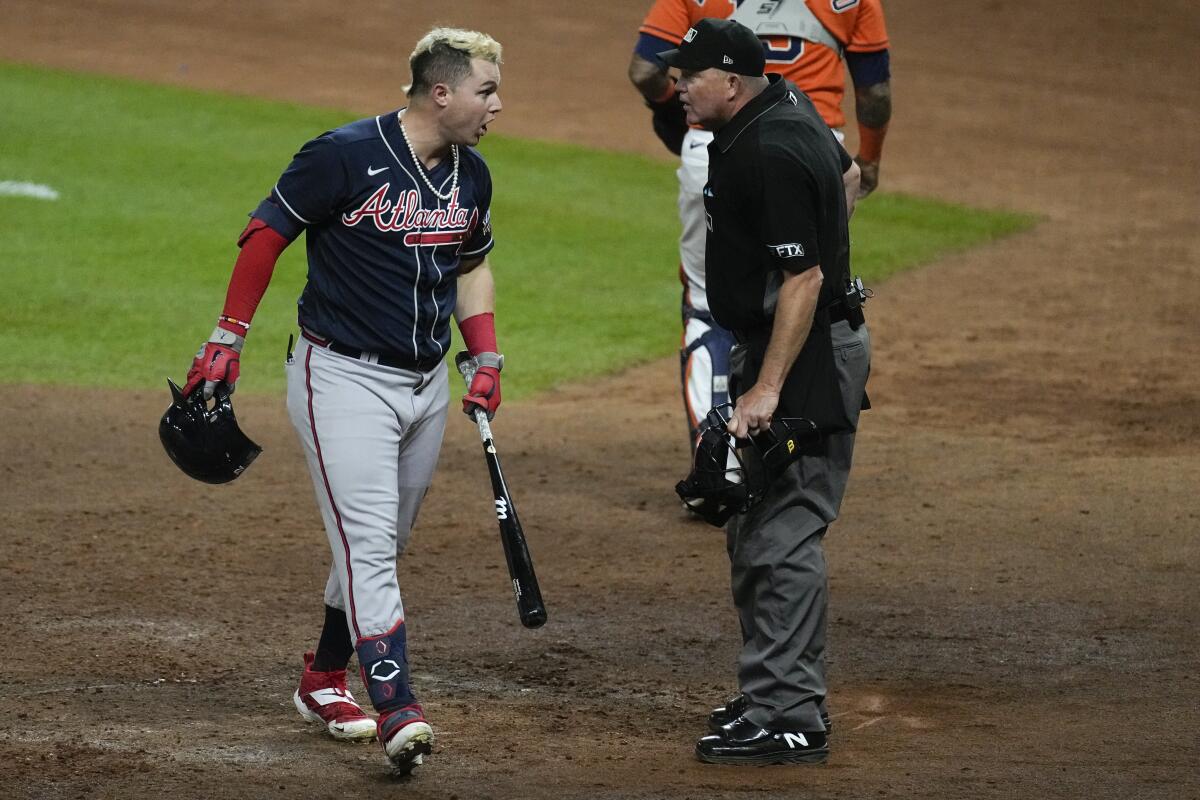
158,380,263,483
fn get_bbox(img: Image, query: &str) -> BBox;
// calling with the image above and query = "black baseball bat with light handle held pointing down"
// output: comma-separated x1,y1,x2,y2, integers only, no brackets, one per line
455,351,546,627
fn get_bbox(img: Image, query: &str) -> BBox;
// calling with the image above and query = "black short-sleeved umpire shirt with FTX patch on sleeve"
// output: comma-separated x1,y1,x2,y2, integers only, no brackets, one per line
704,74,853,432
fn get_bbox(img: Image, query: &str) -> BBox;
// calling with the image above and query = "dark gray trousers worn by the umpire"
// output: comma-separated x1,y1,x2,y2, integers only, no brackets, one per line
726,321,871,732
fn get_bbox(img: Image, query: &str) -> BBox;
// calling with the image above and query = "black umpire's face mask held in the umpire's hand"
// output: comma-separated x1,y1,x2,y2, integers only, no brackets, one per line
676,403,821,527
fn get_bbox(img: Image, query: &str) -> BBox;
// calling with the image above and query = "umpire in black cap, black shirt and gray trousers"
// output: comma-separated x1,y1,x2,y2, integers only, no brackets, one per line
661,19,870,764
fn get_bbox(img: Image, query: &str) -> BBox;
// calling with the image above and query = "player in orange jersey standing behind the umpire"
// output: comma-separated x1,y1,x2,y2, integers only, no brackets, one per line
629,0,892,462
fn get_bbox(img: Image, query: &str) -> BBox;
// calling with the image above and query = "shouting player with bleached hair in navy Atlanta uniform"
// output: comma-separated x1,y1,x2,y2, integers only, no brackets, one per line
185,28,502,772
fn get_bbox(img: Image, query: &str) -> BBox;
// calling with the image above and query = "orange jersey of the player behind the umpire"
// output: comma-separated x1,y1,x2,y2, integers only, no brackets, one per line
638,0,888,128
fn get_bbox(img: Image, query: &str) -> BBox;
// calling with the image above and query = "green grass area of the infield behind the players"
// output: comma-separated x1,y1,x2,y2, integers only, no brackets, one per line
0,65,1032,398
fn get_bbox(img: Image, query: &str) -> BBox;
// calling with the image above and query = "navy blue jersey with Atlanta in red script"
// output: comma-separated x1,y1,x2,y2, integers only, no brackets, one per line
251,112,493,359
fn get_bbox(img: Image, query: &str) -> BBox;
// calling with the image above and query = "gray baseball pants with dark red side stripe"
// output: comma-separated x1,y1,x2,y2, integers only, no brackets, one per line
287,339,450,640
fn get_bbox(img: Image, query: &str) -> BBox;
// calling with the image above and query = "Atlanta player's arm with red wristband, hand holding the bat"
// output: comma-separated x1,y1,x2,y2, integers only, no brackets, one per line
454,255,504,419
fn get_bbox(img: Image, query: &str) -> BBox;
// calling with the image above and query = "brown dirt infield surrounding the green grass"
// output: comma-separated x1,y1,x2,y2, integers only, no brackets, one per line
0,0,1200,800
